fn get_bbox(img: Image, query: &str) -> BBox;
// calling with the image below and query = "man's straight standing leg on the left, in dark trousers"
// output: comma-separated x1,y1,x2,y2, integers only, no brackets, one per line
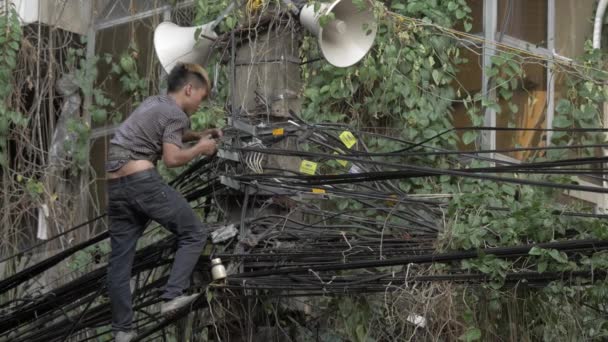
108,202,147,331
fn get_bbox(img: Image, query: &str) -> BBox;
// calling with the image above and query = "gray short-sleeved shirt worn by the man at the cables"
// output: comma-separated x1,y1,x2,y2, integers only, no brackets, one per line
106,95,190,172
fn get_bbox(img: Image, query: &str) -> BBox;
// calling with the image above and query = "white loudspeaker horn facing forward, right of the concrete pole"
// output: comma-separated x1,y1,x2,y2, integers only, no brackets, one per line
300,0,377,68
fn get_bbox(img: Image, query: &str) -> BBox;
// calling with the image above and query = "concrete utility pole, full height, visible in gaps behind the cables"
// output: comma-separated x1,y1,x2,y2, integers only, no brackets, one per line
226,5,302,340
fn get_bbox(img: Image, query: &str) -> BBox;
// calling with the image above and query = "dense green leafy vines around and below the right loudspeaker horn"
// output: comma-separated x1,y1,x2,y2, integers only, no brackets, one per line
302,0,471,147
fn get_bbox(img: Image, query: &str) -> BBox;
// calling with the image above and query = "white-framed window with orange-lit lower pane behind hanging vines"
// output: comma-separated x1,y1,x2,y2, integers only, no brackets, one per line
454,0,556,160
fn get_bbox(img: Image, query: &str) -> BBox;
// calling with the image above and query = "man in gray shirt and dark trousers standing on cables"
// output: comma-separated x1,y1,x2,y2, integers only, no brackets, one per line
106,64,222,342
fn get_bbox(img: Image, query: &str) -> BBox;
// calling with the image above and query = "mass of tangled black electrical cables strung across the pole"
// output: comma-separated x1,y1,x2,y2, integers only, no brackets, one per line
0,111,608,342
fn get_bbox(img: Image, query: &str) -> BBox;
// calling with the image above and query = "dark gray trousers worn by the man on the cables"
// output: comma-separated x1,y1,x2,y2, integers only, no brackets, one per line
108,169,207,331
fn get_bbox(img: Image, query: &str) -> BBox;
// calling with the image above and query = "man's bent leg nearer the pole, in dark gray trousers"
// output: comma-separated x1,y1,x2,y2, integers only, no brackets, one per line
138,181,207,300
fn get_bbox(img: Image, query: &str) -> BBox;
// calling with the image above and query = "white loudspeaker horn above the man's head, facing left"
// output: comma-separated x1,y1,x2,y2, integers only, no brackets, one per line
154,21,217,73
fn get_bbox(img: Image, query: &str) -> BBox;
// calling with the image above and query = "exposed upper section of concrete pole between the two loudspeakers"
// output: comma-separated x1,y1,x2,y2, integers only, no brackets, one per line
232,6,302,171
